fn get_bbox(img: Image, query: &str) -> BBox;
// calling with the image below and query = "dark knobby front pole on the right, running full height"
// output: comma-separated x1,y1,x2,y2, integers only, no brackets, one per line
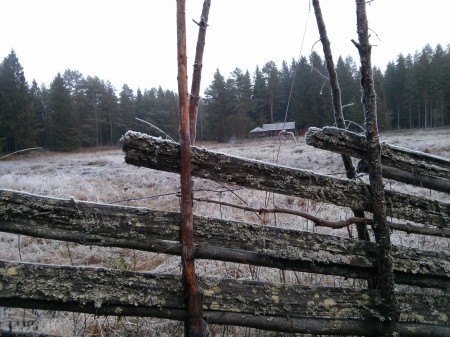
355,0,400,337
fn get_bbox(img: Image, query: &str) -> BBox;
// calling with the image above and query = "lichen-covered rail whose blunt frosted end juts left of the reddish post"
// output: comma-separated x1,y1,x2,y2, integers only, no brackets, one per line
122,131,450,229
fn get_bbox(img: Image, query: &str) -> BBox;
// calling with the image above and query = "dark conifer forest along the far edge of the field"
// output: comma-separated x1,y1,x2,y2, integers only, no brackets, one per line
0,45,450,153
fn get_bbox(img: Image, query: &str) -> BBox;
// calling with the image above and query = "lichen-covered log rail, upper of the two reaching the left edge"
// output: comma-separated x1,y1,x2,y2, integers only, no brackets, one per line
0,190,450,291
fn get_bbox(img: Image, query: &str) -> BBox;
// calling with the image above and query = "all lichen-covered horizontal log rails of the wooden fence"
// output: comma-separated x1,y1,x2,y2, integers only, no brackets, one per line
0,128,450,336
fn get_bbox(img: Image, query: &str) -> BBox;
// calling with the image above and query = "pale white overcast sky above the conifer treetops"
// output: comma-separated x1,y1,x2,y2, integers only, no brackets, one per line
0,0,450,92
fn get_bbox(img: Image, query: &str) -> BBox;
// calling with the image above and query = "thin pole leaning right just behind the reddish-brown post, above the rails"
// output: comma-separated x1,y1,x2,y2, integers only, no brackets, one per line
189,0,211,145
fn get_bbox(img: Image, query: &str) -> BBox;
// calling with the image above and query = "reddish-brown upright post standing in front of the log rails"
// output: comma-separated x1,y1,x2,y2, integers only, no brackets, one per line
177,0,206,337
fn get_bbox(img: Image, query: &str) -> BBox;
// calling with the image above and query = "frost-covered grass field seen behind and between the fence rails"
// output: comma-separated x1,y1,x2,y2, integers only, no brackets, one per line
0,129,450,336
